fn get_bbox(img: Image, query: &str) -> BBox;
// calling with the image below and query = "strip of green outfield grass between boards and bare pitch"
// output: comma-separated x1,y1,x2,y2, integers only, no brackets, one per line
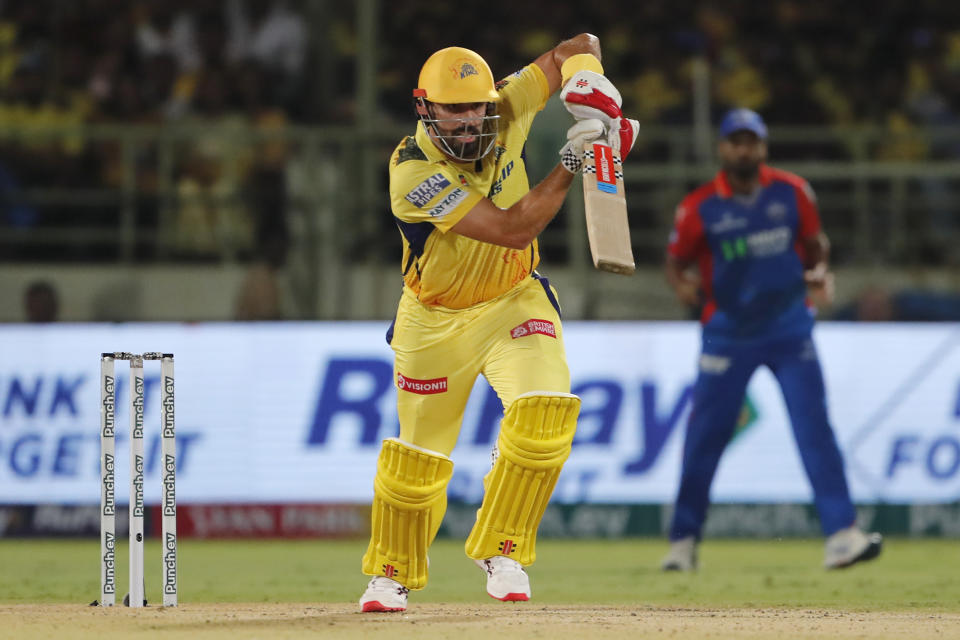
0,539,960,612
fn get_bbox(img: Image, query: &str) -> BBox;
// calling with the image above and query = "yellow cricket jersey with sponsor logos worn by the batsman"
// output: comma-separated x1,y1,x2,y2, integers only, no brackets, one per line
390,64,550,309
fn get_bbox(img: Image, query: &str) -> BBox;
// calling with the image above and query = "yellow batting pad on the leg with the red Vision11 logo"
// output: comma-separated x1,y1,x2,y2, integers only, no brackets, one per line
363,438,453,589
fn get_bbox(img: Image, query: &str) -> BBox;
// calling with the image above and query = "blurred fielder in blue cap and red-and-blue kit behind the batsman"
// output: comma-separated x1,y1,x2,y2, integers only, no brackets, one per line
662,109,882,571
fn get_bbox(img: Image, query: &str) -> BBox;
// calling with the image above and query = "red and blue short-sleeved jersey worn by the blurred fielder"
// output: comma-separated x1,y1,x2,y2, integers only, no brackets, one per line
667,165,820,343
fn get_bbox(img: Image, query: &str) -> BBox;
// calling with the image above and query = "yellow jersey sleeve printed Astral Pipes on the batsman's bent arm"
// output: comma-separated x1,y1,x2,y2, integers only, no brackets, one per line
390,144,483,233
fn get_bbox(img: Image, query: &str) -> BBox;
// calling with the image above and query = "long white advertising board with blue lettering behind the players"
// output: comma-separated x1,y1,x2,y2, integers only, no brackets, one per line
0,322,960,504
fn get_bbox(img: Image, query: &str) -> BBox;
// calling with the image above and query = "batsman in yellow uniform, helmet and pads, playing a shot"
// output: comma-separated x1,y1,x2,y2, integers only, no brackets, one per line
360,34,635,611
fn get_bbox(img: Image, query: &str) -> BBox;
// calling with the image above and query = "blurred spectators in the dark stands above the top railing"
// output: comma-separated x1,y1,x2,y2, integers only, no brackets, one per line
0,0,960,131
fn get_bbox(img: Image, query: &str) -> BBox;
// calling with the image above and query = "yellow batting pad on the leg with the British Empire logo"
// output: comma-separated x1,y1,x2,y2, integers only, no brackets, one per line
466,391,580,565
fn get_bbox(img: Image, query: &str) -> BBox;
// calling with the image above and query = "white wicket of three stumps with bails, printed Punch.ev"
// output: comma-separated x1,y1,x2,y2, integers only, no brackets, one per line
100,352,177,607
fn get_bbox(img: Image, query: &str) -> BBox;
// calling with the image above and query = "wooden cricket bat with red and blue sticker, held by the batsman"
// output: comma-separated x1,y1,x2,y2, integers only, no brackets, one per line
583,142,635,276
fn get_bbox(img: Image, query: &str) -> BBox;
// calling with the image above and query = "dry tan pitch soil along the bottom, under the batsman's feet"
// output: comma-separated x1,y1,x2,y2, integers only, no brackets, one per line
0,603,960,640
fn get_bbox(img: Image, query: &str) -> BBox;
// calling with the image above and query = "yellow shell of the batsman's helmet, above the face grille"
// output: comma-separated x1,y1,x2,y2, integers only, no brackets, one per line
413,47,500,104
